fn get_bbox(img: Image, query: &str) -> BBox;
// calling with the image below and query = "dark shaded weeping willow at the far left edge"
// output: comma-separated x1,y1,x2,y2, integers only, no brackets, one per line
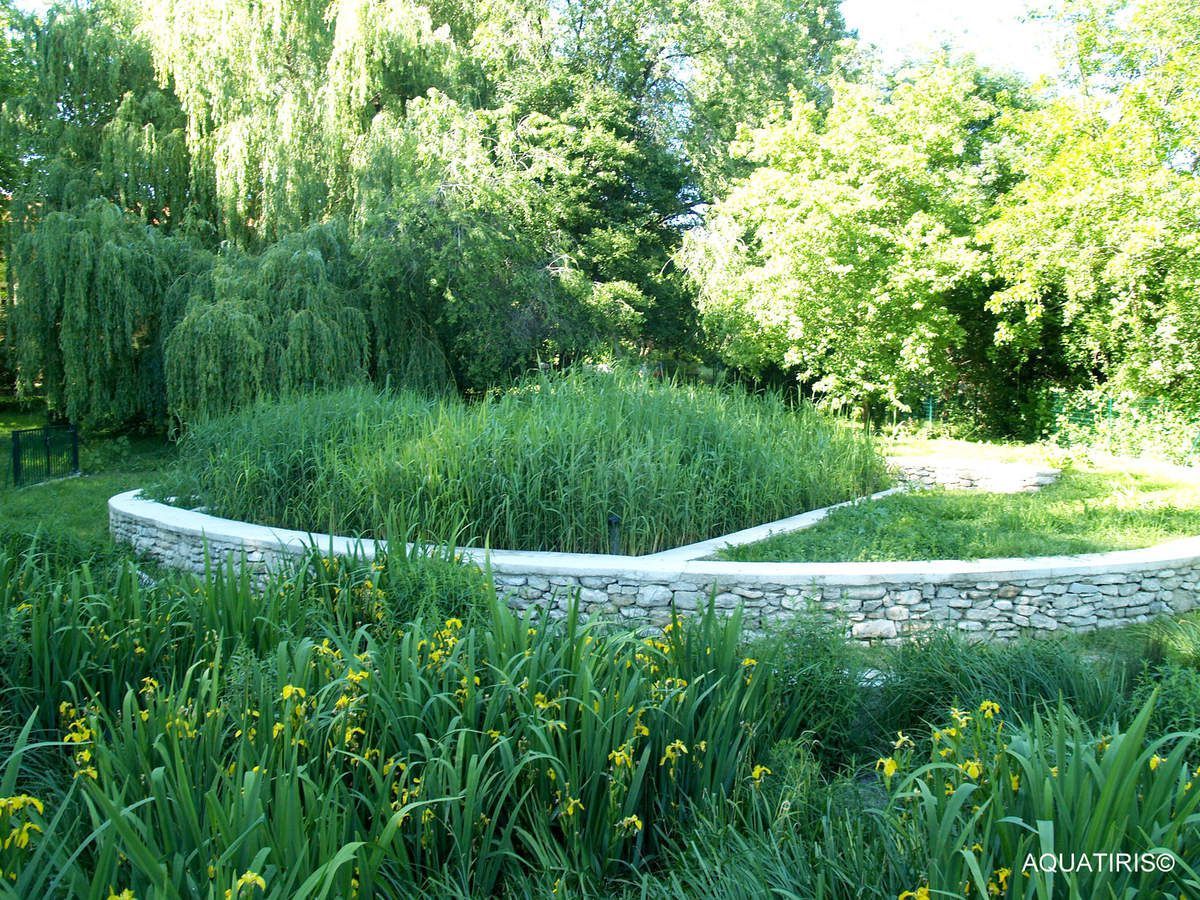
0,0,208,426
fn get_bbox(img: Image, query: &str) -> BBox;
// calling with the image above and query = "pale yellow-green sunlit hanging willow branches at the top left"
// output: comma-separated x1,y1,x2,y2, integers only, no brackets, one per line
139,0,466,246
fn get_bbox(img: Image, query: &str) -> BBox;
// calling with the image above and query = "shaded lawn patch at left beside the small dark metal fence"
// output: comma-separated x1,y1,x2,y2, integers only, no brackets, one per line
0,432,172,546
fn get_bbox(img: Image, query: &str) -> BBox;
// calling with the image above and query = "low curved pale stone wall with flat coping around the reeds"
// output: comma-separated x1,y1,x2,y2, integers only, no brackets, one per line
109,461,1200,641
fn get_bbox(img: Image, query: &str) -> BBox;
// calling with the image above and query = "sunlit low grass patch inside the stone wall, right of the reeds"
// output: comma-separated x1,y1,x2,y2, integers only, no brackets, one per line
721,461,1200,562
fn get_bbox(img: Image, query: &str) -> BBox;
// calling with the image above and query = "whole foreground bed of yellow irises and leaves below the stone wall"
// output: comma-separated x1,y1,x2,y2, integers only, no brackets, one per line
0,532,1200,900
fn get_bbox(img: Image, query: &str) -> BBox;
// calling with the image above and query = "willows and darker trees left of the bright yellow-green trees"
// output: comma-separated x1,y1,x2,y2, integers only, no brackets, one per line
0,0,842,425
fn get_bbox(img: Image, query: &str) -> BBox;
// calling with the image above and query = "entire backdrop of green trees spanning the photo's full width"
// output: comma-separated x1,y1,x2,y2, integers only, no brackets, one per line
0,0,1200,432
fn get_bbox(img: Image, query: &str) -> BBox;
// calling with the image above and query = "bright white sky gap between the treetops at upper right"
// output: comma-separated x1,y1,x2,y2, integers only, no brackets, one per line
841,0,1056,79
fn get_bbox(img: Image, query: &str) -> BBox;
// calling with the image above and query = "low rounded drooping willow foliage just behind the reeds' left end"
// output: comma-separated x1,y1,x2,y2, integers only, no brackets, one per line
166,224,368,421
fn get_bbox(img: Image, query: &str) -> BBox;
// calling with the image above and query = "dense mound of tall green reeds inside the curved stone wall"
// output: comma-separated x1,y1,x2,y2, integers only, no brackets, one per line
158,370,886,554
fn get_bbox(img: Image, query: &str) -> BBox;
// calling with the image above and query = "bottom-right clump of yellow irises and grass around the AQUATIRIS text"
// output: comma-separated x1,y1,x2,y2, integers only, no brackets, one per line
637,697,1200,900
